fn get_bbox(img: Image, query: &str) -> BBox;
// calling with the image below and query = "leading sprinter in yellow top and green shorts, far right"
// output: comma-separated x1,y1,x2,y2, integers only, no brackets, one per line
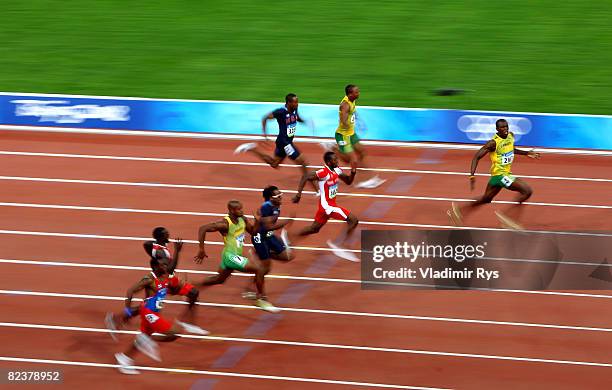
447,119,540,229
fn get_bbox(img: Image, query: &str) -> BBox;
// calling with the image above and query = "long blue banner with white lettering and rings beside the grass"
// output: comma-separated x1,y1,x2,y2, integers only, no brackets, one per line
0,93,612,150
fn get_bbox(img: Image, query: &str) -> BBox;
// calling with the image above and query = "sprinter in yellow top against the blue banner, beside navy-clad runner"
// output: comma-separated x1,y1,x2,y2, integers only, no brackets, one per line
336,84,385,188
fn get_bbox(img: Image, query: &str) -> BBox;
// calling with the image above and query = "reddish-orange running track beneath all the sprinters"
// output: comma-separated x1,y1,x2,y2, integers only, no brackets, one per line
0,132,612,389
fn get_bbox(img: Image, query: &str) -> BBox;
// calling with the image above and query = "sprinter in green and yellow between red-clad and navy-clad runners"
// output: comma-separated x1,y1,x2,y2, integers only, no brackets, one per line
194,200,280,313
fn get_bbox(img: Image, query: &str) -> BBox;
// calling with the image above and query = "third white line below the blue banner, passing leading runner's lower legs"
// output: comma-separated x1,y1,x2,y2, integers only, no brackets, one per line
0,176,612,209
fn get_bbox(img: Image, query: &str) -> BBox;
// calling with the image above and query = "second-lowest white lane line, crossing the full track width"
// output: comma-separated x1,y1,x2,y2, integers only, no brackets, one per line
0,323,612,372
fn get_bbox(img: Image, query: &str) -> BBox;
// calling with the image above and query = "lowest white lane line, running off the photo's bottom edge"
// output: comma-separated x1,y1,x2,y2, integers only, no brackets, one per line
0,356,446,390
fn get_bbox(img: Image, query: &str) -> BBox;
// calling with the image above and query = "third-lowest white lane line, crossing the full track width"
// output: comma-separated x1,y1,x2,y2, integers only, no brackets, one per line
0,290,612,333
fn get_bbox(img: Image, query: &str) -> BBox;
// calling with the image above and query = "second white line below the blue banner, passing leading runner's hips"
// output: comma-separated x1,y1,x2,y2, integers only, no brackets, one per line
0,151,612,183
